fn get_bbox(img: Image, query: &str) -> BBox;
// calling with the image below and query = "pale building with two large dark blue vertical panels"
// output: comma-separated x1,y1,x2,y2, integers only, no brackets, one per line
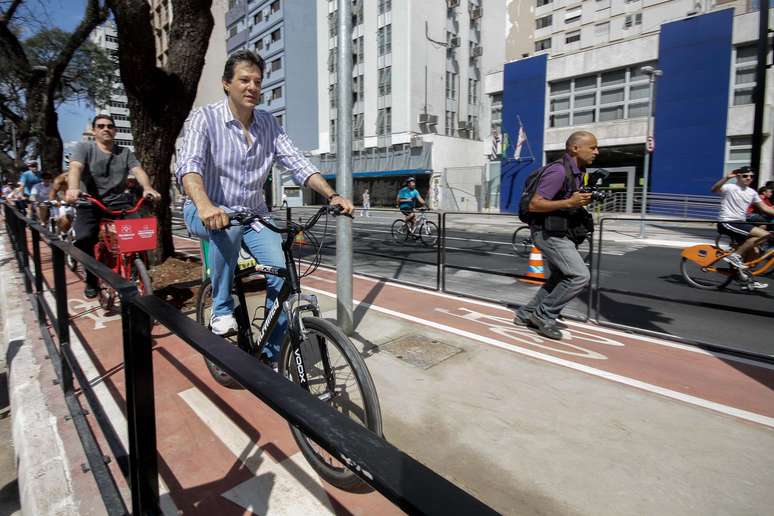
492,0,774,211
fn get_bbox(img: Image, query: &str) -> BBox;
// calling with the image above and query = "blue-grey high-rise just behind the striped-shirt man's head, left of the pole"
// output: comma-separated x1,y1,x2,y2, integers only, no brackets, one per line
226,0,318,150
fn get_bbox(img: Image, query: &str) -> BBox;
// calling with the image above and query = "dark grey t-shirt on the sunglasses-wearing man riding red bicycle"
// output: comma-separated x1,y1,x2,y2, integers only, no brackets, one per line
70,142,140,204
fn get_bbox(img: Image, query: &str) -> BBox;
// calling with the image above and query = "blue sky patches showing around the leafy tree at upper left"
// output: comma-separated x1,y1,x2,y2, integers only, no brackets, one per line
20,0,94,149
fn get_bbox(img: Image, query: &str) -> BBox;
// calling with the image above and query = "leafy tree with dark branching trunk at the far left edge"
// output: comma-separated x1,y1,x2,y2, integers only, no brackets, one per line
0,0,113,175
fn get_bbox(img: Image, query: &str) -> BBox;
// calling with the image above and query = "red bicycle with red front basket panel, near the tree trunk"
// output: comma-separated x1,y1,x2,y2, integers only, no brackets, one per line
82,195,157,311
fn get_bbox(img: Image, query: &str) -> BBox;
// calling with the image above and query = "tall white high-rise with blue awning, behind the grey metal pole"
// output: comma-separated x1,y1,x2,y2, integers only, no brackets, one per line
316,0,505,209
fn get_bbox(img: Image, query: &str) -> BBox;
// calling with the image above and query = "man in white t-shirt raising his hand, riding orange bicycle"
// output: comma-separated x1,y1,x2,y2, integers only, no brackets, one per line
712,167,774,290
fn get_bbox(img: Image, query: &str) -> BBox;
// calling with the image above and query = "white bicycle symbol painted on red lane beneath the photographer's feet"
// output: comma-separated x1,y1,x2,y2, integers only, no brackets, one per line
435,307,625,360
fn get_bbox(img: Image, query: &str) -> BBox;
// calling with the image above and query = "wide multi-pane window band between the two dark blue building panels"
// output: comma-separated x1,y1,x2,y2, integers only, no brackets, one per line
549,63,653,127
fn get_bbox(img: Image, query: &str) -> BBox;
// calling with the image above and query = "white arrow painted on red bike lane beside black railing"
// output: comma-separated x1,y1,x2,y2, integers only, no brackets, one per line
178,387,333,515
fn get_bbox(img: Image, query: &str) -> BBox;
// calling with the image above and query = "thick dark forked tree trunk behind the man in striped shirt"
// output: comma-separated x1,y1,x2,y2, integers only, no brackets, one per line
108,0,218,261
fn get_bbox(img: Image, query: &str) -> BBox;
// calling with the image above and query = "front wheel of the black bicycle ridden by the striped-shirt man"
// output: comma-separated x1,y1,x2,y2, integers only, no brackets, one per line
279,317,382,491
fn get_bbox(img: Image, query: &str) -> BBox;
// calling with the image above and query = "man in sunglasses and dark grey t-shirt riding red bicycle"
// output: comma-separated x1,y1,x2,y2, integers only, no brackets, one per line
65,114,161,299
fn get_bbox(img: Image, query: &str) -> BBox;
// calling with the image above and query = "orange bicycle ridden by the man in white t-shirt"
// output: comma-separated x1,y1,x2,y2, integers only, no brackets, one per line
680,236,774,290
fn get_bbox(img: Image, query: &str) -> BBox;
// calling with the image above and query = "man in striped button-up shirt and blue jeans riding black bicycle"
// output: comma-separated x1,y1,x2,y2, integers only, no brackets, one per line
176,50,353,363
